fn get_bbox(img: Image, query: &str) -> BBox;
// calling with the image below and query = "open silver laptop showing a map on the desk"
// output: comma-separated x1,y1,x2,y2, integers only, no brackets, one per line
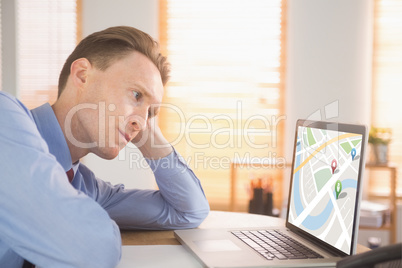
175,120,367,267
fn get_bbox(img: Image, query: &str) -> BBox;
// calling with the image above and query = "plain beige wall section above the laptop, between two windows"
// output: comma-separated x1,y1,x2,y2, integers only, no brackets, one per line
284,0,373,211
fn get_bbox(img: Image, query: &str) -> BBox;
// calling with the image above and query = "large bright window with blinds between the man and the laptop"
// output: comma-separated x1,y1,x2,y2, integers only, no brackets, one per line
160,0,285,210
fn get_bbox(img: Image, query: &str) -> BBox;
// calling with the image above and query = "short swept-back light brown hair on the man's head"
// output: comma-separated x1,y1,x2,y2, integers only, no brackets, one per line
58,26,170,96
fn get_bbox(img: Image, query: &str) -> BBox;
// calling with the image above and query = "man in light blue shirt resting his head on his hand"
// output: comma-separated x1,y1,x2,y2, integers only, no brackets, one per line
0,27,209,268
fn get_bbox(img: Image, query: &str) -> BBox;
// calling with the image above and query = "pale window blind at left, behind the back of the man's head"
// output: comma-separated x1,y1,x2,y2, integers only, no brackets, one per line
17,0,77,108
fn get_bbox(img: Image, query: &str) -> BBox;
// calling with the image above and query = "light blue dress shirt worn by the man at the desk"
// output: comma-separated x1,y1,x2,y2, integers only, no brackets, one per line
0,92,209,268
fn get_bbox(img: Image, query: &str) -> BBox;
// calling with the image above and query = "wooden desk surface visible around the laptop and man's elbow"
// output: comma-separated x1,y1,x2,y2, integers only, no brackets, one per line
121,211,369,253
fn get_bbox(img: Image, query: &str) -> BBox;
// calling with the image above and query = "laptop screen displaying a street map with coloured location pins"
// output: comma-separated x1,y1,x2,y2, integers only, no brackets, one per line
288,122,365,254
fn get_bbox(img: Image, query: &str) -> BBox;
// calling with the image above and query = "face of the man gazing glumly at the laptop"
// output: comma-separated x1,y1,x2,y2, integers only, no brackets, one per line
75,52,163,159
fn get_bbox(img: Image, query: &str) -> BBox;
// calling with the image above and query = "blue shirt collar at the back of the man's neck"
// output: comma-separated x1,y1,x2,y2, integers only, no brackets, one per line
31,103,72,171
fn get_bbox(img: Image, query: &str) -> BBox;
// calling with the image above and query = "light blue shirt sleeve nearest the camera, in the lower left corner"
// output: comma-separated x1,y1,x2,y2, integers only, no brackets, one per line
0,93,121,267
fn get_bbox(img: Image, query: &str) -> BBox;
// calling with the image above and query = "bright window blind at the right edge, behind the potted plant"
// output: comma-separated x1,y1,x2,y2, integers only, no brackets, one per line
372,0,402,196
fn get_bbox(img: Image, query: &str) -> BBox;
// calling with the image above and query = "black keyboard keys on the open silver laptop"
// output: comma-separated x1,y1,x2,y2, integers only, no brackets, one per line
232,230,322,260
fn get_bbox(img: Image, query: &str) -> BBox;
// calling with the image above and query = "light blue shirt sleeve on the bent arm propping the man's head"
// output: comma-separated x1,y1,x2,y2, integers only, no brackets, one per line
84,150,209,230
